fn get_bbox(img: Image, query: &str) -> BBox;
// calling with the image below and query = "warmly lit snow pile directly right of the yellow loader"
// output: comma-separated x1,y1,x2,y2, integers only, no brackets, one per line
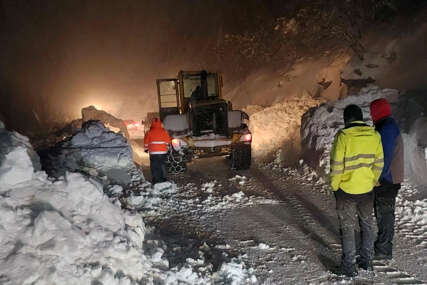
248,93,322,164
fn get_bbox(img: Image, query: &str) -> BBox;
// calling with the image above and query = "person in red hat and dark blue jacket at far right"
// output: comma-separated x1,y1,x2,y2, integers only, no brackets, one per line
370,98,404,259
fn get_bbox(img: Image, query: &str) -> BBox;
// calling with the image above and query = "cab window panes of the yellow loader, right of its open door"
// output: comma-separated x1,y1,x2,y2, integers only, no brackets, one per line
183,73,218,98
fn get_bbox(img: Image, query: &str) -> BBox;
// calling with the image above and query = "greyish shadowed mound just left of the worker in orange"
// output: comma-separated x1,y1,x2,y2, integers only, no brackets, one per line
44,121,140,184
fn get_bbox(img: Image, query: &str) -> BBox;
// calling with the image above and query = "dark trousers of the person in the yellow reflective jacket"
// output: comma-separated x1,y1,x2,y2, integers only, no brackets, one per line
334,189,374,272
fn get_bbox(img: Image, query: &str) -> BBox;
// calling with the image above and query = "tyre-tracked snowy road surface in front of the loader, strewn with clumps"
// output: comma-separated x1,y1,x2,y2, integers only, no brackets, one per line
140,157,427,284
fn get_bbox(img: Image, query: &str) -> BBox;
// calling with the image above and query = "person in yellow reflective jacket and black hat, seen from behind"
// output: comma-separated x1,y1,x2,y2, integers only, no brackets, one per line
330,105,384,276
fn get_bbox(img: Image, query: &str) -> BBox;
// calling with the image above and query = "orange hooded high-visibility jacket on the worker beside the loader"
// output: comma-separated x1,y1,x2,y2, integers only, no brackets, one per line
144,118,171,154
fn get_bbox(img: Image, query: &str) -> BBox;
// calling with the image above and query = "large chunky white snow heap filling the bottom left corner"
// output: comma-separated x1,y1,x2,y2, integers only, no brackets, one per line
0,171,151,284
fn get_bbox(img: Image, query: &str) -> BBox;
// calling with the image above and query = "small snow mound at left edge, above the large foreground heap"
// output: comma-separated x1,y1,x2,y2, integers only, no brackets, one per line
0,121,41,191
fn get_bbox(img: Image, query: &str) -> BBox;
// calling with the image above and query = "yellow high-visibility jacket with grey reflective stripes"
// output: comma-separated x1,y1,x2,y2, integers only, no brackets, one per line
329,121,384,194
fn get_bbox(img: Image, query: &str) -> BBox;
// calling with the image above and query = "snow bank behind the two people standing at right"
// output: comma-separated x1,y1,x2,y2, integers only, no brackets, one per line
301,86,427,185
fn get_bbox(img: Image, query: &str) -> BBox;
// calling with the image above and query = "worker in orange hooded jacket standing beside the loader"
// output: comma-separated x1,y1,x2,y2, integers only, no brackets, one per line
144,118,171,185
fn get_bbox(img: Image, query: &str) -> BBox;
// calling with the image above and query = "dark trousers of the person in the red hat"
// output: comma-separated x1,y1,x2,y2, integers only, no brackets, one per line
374,180,400,258
